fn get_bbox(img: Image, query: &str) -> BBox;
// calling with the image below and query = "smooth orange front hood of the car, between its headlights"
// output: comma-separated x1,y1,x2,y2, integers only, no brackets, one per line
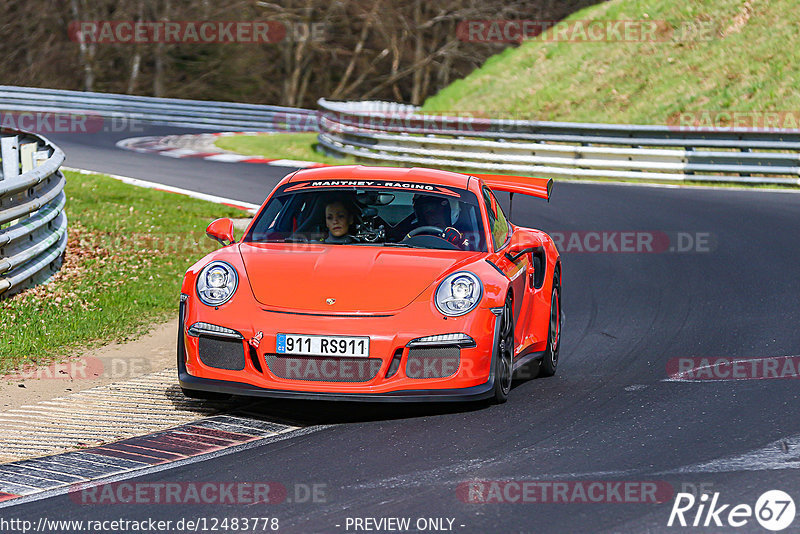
239,243,481,314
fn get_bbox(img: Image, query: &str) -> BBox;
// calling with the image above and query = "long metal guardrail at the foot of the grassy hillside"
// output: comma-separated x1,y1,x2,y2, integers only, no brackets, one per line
318,99,800,185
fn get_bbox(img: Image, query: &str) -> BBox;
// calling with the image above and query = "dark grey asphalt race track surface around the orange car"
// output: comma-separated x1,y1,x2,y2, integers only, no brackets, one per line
6,125,800,533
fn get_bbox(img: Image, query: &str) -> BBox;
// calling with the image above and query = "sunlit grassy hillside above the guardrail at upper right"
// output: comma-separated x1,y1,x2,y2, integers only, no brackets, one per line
424,0,800,127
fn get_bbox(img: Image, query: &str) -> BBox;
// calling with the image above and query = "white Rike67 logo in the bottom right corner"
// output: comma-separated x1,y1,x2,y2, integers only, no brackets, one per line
667,490,795,532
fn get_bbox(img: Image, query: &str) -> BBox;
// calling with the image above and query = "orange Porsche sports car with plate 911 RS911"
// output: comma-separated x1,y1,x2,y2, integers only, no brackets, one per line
178,166,563,403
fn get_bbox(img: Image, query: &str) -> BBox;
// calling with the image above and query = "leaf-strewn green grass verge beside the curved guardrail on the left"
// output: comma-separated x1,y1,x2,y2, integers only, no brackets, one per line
0,171,242,374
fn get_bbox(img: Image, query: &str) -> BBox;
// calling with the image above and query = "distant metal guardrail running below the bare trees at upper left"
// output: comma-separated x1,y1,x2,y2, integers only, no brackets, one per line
0,85,317,132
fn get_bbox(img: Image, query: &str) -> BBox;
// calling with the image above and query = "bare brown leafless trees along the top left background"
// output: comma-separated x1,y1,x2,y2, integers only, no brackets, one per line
0,0,600,107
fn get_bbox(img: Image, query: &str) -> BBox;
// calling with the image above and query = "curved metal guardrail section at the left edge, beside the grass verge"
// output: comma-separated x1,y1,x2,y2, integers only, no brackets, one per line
0,130,67,299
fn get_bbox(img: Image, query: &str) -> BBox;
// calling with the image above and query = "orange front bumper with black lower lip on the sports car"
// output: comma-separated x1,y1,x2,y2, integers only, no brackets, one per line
178,302,499,402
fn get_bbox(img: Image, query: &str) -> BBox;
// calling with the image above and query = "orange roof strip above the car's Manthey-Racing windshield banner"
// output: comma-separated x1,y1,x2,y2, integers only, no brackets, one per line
289,165,470,189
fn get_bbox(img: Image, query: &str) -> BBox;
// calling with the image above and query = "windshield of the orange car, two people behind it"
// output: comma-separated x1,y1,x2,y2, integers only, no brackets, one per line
244,181,486,252
